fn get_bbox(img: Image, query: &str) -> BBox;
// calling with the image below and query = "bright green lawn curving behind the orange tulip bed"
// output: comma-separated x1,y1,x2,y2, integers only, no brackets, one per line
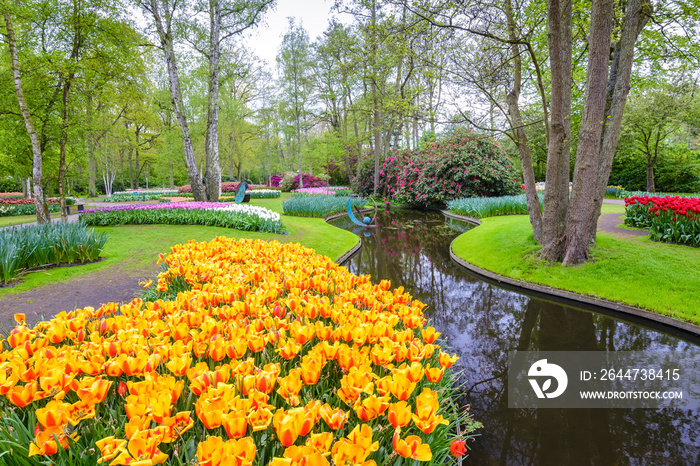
0,194,359,295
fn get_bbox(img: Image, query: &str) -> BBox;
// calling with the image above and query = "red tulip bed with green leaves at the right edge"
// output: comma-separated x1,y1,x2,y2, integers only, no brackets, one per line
625,196,700,246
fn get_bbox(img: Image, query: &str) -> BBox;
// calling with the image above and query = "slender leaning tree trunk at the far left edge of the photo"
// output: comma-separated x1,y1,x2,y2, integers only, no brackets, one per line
2,9,51,224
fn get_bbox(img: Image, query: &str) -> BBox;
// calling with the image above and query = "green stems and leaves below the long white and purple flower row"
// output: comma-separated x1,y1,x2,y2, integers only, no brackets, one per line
77,209,286,233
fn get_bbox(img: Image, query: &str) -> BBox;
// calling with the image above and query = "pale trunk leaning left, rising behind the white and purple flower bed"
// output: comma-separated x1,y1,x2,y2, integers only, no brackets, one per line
150,0,206,198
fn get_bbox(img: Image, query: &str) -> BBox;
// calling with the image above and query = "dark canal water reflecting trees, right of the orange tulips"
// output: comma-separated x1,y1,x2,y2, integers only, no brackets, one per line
332,210,700,466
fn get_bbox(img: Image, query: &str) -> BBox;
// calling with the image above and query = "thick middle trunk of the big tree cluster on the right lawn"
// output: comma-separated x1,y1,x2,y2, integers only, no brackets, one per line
562,0,613,265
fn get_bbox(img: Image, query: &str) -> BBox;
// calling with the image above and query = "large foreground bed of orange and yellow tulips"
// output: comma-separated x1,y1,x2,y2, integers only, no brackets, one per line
0,237,478,466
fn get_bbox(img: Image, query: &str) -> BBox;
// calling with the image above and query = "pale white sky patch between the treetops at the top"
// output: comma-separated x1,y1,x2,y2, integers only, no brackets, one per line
244,0,346,69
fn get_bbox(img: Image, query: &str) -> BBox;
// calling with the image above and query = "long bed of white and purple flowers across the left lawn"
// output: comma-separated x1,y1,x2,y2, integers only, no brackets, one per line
82,202,285,233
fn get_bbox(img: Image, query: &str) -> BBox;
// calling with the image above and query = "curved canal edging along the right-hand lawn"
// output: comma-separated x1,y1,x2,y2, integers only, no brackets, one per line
443,228,700,336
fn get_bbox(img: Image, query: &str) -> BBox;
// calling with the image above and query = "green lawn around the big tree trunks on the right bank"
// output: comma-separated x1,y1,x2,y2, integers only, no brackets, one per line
453,215,700,324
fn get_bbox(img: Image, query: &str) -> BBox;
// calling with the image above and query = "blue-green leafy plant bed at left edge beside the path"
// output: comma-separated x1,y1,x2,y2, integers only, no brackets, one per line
0,223,107,283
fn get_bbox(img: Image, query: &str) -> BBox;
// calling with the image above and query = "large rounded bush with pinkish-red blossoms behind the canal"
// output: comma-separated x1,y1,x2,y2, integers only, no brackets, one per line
355,129,520,207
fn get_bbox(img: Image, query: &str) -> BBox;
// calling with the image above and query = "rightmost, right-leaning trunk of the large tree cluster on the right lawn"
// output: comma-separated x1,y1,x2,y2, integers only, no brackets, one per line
589,0,653,242
